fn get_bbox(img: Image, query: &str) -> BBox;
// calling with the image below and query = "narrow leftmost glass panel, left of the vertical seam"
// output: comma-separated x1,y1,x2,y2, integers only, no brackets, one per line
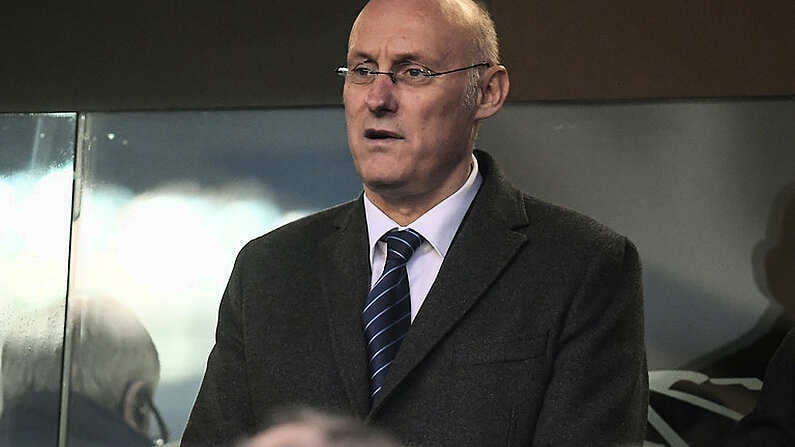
0,113,76,447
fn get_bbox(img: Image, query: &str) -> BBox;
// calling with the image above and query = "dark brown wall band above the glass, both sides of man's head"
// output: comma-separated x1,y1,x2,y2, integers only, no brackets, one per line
0,0,795,112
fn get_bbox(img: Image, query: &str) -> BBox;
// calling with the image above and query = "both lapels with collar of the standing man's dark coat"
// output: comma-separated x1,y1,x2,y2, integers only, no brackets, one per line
323,151,529,416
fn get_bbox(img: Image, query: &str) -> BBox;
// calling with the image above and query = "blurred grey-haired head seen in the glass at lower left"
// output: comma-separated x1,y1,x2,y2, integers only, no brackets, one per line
0,298,160,433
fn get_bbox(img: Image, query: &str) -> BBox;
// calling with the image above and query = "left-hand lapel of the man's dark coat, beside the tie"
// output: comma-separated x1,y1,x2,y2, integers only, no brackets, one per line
321,198,370,416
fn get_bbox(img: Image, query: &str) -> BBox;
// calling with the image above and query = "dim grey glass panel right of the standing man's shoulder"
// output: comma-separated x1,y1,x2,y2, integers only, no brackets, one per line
480,100,795,445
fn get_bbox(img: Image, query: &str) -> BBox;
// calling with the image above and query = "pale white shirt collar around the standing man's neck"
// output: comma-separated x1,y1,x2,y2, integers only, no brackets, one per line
364,155,483,262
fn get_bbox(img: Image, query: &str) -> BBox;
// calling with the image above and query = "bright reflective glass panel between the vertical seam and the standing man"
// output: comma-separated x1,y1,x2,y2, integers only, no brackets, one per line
70,109,361,440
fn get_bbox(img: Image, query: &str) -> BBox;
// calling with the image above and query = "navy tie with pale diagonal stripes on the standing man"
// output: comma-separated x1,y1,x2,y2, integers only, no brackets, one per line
362,228,423,402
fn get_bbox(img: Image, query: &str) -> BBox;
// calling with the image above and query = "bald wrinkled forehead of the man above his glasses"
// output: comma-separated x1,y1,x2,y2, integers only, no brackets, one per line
348,0,471,63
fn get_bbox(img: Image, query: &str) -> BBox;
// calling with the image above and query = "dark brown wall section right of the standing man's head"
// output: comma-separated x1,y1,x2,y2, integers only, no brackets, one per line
492,0,795,100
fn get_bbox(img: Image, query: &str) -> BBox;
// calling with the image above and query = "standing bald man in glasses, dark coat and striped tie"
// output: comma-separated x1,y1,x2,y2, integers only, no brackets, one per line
183,0,647,447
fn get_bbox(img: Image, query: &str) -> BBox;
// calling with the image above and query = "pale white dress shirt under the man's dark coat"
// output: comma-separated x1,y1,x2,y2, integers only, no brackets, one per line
364,156,483,322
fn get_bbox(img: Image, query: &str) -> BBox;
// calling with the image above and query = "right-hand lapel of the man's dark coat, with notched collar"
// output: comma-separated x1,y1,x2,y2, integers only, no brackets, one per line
370,153,529,415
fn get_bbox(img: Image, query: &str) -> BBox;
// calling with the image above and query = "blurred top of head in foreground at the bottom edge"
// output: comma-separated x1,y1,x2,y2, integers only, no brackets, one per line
239,409,400,447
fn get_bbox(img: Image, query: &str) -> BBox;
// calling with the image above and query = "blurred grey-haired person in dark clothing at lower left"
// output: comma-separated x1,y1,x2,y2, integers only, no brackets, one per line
0,298,164,447
